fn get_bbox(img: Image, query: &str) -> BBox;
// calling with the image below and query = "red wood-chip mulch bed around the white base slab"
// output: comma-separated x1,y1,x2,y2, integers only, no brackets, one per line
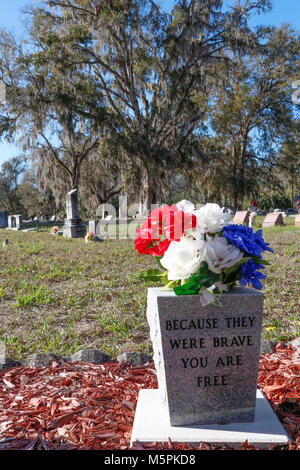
0,343,300,450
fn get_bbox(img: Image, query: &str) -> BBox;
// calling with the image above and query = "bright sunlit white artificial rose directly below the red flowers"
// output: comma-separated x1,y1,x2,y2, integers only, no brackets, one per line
160,237,205,281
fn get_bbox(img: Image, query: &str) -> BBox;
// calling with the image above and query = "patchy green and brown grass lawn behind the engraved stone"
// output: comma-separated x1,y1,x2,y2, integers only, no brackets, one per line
0,217,300,359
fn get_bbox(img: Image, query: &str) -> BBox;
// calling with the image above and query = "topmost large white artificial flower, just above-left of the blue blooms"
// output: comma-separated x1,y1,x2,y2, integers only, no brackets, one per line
194,203,232,233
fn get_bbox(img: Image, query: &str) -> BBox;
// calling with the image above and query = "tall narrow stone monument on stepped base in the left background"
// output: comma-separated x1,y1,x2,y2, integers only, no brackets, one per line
63,189,86,238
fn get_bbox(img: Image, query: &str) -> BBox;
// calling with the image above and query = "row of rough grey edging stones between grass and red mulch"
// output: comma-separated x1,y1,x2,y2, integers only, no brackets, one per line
0,337,300,371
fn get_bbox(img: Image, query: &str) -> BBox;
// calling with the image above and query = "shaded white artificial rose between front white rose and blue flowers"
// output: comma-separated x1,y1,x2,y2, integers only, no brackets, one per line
205,237,244,274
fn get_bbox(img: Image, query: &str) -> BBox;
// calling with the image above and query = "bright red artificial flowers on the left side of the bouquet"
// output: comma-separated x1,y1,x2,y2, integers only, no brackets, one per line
134,204,196,256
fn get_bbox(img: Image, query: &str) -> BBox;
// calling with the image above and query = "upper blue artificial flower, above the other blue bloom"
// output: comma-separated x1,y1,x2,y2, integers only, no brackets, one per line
222,224,273,258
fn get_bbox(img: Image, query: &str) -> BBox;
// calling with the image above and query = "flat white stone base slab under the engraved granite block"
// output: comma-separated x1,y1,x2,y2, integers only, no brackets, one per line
130,389,289,448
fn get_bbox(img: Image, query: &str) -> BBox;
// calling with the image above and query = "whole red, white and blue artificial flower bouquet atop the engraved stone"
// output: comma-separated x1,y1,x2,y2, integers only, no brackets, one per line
134,200,273,306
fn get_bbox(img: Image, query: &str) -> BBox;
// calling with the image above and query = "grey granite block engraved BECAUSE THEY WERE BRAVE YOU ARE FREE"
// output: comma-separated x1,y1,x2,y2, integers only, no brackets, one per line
147,287,264,426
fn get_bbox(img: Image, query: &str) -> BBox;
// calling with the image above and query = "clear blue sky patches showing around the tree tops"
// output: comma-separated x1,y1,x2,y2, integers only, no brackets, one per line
0,0,300,165
